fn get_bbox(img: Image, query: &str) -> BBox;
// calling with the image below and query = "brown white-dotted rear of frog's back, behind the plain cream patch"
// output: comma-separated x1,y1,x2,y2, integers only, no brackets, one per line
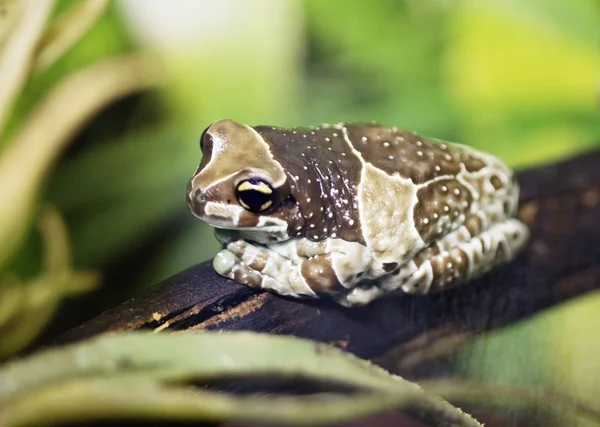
344,124,518,243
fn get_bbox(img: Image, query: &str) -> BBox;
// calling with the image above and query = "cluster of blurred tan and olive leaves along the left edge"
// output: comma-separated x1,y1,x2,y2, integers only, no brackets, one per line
0,0,154,357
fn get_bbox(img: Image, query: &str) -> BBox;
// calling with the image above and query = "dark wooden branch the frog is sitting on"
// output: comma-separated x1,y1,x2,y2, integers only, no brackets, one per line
61,151,600,373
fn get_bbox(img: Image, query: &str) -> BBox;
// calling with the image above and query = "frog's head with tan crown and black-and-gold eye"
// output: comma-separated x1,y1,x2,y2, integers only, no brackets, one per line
187,120,302,243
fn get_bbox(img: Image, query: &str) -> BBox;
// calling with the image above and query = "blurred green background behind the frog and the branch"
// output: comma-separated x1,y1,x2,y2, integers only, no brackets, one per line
0,0,600,424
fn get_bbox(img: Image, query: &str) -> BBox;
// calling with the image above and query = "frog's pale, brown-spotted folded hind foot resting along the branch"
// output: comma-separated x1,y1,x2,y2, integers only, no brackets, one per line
340,219,529,306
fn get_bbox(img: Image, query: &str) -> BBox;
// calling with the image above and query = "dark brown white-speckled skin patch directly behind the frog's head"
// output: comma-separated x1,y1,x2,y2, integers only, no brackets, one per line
254,126,364,243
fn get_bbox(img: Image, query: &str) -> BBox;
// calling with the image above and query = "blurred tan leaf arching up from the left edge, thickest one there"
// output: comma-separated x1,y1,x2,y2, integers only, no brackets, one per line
0,51,157,267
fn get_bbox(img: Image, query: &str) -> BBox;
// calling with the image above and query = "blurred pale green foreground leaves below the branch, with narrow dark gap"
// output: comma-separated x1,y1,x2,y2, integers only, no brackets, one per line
0,332,481,426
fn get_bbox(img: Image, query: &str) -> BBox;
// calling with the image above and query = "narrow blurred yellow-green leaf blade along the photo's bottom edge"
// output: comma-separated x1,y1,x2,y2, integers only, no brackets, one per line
0,378,418,427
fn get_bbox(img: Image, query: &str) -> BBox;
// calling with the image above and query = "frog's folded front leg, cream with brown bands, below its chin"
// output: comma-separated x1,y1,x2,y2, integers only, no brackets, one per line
214,239,372,297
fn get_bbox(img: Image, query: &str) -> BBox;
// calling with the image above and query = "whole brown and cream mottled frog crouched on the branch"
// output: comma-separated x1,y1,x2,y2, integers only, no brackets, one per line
187,119,529,307
